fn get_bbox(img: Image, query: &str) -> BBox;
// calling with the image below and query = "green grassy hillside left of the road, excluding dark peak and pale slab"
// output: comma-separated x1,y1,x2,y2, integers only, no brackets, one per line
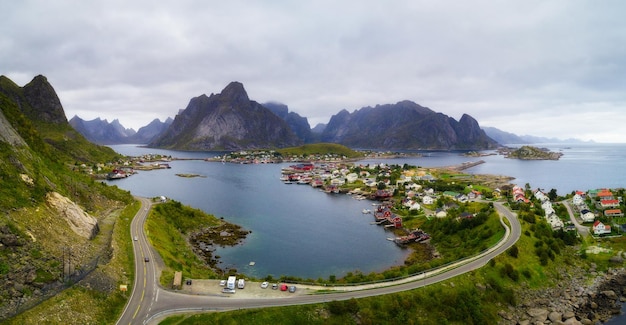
0,77,138,324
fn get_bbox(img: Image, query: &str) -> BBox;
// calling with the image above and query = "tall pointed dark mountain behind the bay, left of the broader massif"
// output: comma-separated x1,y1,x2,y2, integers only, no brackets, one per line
149,82,303,151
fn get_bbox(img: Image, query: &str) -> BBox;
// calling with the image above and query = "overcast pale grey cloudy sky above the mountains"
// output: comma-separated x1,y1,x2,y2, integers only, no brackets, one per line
0,0,626,143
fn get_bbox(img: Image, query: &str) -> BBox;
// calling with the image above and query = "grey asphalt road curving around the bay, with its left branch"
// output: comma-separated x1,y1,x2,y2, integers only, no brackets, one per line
118,198,521,324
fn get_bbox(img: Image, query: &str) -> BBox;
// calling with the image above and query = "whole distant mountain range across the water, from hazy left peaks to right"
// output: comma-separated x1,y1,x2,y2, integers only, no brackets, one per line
70,82,575,151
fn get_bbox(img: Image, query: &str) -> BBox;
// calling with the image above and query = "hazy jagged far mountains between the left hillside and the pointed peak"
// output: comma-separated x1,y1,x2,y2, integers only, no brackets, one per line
70,116,136,144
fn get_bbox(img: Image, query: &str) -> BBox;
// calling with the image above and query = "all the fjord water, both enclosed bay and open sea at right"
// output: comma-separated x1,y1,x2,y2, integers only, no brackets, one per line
109,144,626,279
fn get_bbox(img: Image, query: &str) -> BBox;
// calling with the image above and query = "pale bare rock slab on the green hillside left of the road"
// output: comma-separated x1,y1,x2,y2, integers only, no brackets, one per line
46,192,99,239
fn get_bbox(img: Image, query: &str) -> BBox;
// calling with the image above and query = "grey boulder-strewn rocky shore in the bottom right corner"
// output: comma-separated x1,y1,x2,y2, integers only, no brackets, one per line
499,264,626,325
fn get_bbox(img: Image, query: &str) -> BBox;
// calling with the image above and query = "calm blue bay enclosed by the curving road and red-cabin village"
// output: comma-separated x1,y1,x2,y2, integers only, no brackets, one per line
109,146,408,279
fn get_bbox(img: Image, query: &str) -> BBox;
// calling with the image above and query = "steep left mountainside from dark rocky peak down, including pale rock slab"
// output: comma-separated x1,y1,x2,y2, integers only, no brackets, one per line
0,76,132,322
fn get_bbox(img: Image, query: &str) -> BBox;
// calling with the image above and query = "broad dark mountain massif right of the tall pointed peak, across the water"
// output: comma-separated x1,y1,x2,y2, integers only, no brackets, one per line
321,101,498,150
